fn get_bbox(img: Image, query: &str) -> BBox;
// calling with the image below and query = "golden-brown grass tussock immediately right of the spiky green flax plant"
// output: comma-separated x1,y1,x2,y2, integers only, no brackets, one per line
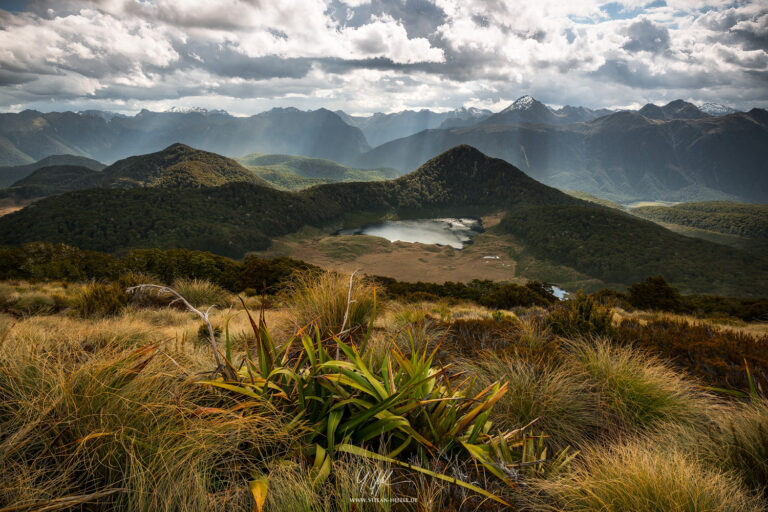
458,352,602,449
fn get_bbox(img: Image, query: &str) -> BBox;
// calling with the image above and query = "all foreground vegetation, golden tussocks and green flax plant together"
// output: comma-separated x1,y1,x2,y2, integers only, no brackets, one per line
0,266,768,512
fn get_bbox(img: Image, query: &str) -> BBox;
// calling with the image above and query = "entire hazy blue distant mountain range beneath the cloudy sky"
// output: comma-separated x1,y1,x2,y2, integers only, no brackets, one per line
0,96,768,202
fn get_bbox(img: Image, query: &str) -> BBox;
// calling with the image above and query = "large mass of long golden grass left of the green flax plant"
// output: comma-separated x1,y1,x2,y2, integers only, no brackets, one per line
0,323,293,512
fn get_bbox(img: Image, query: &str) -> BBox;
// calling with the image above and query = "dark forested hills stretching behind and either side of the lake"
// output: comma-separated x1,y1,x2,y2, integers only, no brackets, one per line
0,145,768,295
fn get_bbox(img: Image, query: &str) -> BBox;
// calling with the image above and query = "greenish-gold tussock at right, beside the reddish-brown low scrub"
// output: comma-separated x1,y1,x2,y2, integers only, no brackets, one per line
568,338,710,430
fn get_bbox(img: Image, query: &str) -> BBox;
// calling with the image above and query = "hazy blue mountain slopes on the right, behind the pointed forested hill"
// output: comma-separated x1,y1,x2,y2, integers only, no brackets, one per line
355,109,768,202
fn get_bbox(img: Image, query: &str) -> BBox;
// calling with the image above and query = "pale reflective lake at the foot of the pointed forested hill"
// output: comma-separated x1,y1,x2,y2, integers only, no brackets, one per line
337,218,483,249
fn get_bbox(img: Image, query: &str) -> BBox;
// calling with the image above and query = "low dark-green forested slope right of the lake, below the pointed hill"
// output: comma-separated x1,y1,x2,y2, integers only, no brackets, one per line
499,204,768,296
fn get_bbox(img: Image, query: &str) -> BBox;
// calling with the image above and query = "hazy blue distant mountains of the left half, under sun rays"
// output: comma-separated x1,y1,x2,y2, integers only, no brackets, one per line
0,108,370,165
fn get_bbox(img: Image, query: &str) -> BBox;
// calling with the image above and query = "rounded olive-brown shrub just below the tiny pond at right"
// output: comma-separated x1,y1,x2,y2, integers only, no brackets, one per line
546,293,613,337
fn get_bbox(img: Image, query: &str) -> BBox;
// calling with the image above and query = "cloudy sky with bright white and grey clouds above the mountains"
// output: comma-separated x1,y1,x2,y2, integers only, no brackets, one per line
0,0,768,115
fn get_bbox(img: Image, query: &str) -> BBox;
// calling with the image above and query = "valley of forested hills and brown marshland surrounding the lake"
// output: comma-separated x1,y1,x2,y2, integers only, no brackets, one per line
0,144,768,296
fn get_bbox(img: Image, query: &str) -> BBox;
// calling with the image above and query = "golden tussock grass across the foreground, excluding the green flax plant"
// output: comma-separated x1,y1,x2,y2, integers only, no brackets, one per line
0,276,768,512
